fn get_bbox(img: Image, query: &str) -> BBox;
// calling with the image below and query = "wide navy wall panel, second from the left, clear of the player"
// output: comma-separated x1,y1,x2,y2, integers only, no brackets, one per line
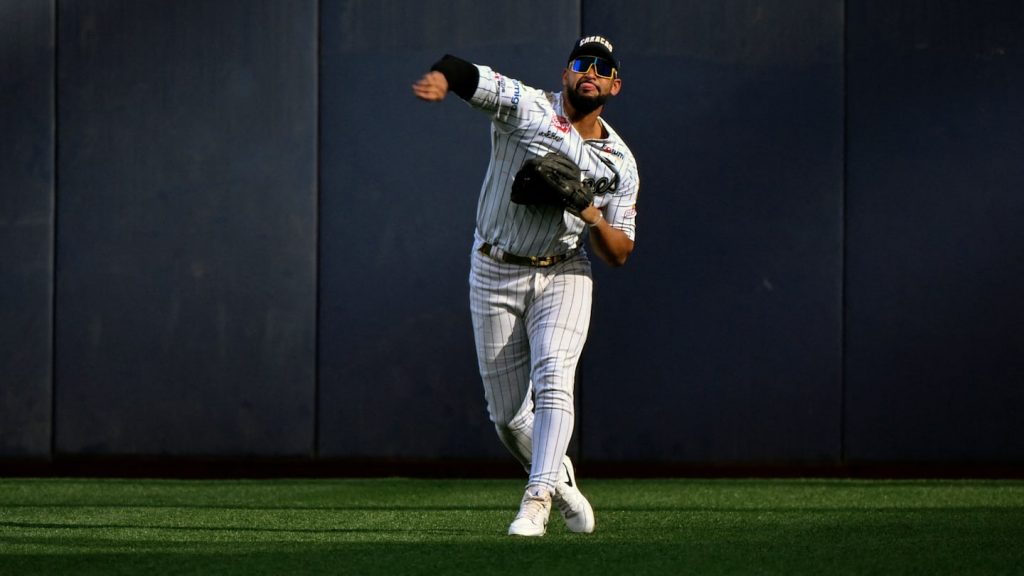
55,0,316,456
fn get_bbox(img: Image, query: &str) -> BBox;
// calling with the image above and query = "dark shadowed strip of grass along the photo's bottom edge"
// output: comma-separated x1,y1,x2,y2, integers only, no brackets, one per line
0,537,1022,576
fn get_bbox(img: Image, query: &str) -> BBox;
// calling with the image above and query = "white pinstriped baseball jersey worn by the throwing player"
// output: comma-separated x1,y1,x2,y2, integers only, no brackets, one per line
468,66,640,256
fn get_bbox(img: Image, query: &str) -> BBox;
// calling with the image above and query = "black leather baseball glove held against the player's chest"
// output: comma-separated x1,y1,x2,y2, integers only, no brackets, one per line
512,152,594,216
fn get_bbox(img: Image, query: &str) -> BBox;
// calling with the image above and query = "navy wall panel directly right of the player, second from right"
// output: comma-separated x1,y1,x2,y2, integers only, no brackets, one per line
581,0,843,463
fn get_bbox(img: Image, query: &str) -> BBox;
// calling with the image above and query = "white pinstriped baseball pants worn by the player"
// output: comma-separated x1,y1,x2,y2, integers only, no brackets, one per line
469,250,594,490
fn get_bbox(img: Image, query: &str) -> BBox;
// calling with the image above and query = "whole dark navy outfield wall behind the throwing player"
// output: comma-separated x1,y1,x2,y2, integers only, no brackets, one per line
0,0,1024,469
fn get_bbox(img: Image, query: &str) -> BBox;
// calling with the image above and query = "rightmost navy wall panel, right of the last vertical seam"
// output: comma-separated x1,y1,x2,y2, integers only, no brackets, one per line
846,0,1024,463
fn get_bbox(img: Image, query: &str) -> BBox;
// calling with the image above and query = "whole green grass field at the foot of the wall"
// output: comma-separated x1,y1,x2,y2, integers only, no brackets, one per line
0,479,1024,576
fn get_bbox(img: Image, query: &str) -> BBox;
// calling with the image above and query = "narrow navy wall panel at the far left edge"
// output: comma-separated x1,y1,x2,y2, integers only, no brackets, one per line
0,0,53,457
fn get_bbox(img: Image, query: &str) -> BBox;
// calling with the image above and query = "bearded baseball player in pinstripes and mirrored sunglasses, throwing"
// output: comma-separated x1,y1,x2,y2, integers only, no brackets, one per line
413,36,640,536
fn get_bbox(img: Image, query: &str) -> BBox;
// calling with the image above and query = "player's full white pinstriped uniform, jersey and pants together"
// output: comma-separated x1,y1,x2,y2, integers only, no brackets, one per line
460,66,639,492
